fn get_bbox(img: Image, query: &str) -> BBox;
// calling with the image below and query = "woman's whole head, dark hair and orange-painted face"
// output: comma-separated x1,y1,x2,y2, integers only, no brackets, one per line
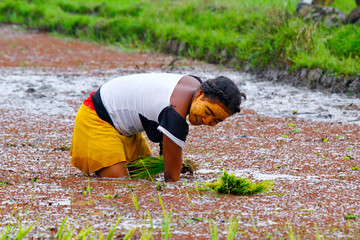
189,76,246,126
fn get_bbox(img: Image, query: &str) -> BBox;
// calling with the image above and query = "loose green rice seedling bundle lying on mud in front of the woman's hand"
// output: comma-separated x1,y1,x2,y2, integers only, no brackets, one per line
205,171,274,195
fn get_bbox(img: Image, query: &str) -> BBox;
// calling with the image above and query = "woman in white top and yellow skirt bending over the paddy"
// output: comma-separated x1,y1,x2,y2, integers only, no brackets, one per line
70,73,246,182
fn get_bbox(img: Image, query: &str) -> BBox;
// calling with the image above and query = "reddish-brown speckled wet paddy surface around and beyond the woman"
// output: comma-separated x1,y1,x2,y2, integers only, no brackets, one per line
0,27,360,239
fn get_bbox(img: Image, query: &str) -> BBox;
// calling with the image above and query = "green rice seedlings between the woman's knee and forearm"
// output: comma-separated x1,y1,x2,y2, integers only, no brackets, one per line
127,156,165,179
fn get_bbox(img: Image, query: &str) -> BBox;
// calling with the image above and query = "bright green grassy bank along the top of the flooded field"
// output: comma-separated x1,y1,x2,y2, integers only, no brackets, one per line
0,0,360,74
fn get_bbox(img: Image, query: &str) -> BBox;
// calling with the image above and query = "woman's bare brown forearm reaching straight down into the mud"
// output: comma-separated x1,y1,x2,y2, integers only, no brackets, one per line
163,135,182,182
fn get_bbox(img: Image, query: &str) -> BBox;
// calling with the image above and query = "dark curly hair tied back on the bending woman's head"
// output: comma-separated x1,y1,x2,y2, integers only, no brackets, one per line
200,76,246,115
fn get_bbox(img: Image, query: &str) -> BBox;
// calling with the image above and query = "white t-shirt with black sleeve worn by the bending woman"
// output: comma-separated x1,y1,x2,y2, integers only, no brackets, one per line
100,73,187,147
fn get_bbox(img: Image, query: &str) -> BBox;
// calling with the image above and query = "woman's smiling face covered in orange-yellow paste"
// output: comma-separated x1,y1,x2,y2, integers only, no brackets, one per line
189,90,230,126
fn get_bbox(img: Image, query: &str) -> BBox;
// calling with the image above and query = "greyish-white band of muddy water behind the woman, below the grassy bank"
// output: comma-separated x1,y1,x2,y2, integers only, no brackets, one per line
0,69,360,124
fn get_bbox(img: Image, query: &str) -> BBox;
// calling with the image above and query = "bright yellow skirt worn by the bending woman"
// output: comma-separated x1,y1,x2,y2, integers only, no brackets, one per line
70,104,151,174
